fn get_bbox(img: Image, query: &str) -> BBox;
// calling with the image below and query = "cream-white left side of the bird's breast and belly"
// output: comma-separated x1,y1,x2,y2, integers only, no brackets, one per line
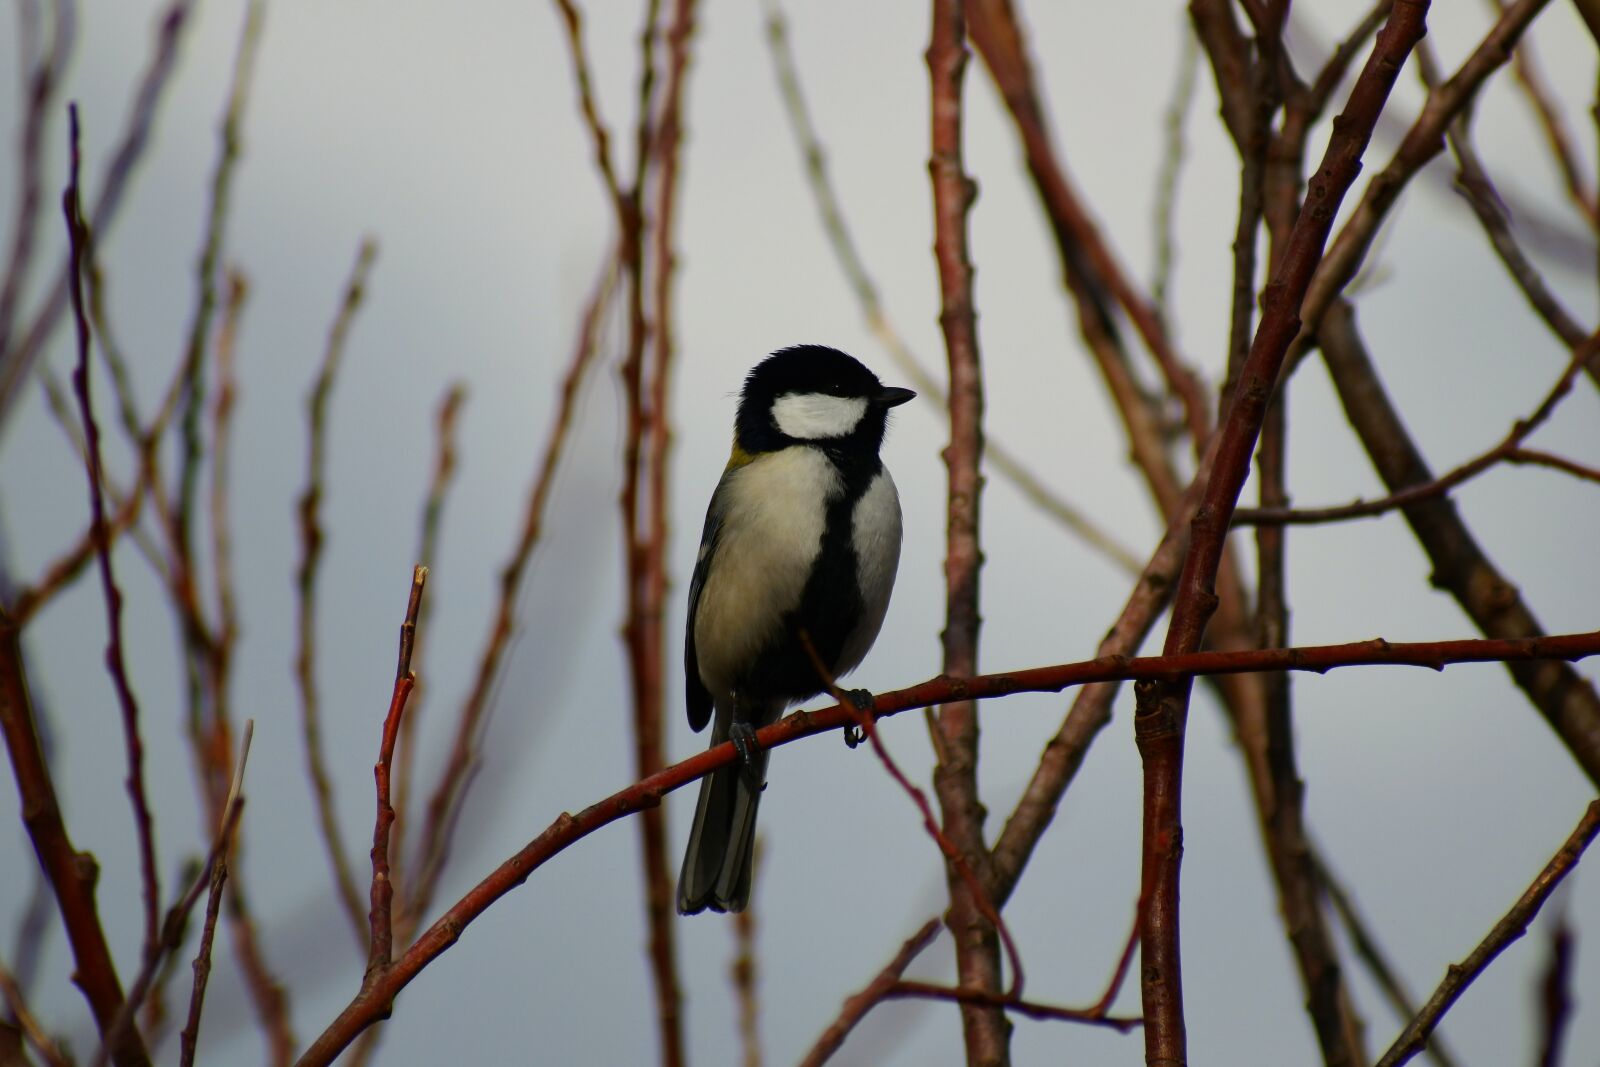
694,446,844,697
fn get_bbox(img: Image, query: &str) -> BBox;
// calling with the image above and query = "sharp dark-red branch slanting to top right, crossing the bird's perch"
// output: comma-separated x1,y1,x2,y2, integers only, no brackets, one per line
1134,0,1429,1064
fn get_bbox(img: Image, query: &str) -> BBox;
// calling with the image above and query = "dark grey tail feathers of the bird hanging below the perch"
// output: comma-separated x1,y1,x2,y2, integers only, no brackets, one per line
678,723,766,915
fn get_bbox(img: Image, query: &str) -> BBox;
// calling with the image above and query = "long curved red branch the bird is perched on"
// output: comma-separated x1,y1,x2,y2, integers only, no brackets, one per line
291,630,1600,1067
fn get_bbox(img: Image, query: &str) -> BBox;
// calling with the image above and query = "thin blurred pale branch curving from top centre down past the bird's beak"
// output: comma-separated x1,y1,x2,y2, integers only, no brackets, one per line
763,0,1141,574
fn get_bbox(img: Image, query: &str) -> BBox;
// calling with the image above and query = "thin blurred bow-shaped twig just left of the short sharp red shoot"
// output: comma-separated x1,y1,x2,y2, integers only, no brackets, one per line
294,238,378,942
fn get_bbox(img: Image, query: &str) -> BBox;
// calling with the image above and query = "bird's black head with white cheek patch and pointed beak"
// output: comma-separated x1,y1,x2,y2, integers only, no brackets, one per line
734,344,917,454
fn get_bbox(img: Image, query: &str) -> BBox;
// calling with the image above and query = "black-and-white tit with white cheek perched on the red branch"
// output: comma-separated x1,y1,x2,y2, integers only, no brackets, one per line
677,344,917,915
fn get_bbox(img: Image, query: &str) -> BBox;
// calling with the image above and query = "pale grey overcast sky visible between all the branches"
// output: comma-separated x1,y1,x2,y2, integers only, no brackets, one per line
0,2,1600,1064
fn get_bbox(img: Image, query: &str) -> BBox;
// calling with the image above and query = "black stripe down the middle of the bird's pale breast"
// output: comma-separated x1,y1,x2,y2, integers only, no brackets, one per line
736,448,883,701
